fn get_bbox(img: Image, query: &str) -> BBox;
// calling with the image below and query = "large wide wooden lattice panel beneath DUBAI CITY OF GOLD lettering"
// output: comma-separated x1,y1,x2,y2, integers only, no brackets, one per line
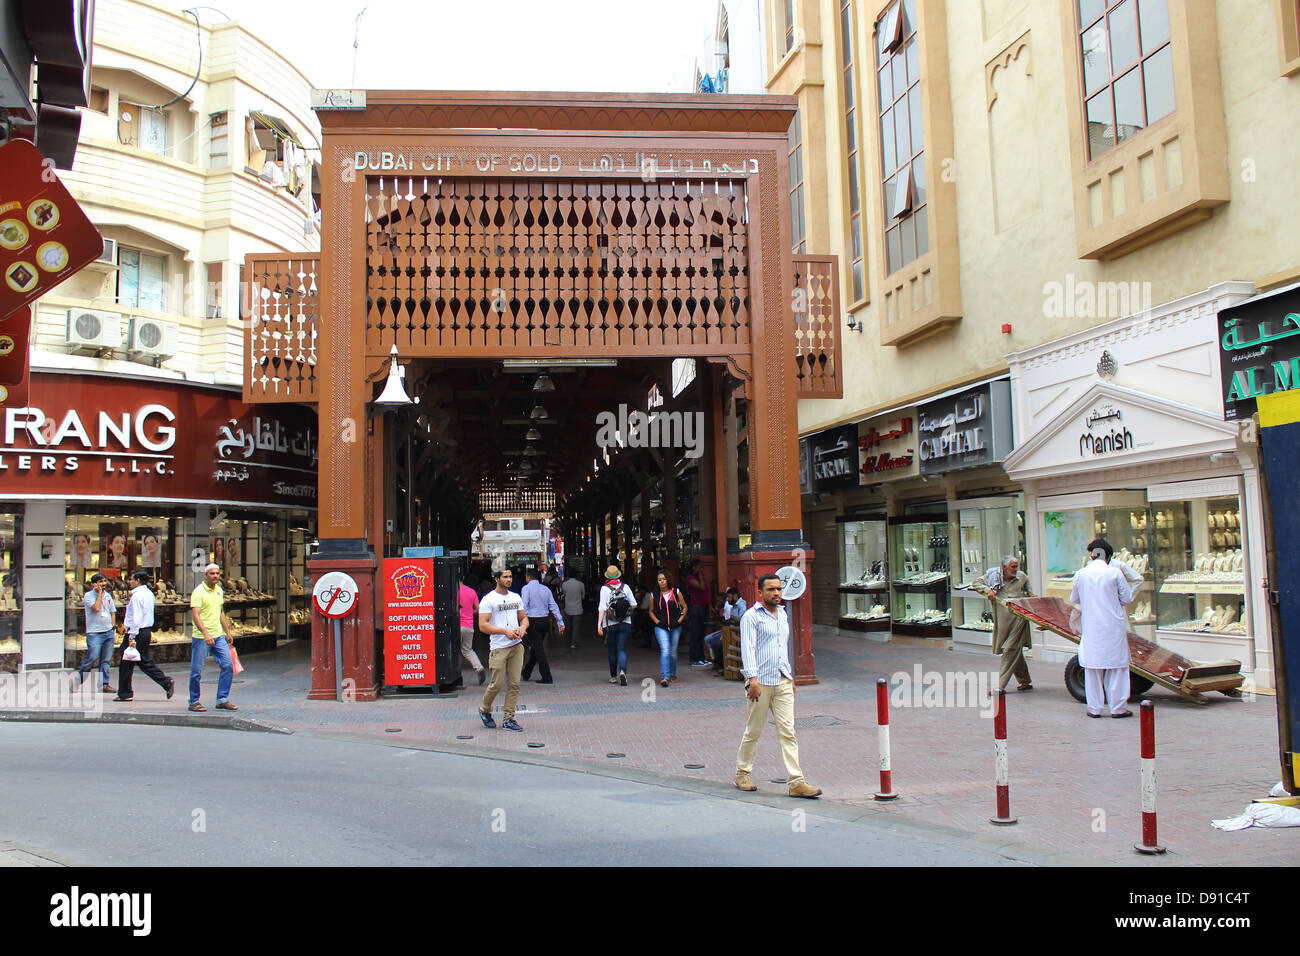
365,177,750,356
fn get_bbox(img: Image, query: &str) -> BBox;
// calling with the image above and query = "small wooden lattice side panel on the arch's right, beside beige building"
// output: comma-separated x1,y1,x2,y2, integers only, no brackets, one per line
793,255,844,398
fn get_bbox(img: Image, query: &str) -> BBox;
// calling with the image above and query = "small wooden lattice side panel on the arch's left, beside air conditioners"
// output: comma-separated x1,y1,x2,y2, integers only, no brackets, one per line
243,255,320,403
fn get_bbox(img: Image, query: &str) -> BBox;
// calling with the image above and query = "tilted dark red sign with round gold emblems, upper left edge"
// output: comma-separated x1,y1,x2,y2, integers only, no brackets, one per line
0,139,104,316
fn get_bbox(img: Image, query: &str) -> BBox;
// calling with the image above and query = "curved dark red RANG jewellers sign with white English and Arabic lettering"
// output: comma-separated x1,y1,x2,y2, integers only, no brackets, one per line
0,372,317,509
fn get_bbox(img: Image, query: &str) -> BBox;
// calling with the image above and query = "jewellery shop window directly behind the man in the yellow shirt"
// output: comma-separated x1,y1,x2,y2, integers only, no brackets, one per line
209,518,278,650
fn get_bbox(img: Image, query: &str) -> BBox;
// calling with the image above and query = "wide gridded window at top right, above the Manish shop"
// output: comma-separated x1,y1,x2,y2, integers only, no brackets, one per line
1076,0,1174,160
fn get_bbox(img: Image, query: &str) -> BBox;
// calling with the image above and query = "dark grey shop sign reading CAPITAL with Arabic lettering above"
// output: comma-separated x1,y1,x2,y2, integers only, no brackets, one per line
917,378,1013,475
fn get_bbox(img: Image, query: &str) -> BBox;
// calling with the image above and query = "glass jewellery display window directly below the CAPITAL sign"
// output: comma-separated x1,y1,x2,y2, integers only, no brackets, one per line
952,497,1026,632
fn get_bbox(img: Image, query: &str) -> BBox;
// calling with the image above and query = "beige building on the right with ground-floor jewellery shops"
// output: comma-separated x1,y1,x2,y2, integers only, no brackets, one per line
766,0,1300,685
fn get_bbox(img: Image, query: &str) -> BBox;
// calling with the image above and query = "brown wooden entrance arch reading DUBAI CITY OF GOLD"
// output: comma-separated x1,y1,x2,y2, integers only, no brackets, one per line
244,91,841,700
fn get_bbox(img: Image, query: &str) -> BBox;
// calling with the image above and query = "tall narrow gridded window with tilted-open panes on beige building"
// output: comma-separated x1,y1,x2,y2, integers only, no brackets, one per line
876,0,930,274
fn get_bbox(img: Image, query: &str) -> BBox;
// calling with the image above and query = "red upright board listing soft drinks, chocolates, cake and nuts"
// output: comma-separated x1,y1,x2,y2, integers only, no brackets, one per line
384,558,438,687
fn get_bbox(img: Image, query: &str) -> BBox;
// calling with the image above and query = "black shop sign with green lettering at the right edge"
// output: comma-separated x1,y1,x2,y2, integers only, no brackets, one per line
1218,289,1300,421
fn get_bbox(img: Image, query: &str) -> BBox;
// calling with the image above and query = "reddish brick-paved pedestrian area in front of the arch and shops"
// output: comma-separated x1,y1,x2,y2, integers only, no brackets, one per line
12,628,1300,866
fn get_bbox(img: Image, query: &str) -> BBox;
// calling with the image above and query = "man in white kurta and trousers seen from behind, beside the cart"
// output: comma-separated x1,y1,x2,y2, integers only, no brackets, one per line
1070,540,1134,717
